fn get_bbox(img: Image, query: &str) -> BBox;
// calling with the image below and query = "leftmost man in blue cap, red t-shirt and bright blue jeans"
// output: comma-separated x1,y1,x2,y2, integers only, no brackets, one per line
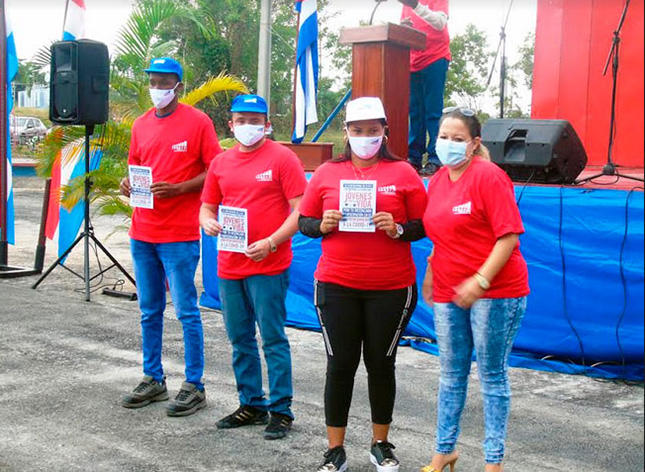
121,58,222,416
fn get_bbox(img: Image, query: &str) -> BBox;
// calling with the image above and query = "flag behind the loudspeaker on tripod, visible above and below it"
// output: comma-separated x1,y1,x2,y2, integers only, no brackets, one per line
45,0,95,257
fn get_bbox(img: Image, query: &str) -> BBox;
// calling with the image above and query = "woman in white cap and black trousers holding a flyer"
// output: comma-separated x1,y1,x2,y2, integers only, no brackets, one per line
300,97,426,472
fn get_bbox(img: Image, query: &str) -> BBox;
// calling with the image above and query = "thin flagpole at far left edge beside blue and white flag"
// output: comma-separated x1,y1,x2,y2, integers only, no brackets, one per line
0,0,9,266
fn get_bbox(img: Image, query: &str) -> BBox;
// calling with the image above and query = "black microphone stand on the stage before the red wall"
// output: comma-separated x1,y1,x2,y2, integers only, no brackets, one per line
576,0,643,185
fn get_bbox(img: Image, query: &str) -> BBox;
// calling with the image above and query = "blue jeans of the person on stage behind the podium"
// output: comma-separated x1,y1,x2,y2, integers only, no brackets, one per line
408,59,450,166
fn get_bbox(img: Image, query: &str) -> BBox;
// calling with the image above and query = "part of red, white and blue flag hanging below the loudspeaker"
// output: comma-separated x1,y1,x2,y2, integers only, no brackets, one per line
45,138,103,257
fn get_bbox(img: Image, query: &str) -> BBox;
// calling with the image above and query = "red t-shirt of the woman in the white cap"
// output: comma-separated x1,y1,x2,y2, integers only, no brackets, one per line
300,161,426,290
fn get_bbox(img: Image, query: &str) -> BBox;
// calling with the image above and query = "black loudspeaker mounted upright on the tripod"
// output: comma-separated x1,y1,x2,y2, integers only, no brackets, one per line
49,39,110,126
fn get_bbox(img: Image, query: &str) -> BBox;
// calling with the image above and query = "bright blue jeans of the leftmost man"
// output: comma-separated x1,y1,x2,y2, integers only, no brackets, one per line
130,239,204,390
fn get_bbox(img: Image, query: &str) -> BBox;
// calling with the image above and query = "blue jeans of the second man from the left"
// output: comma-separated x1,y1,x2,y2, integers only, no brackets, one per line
219,272,293,418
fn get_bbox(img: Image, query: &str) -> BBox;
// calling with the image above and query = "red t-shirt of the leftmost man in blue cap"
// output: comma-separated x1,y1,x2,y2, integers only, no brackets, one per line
128,104,222,243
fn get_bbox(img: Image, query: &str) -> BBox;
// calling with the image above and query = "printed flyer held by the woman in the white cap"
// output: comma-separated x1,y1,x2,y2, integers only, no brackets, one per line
338,180,376,233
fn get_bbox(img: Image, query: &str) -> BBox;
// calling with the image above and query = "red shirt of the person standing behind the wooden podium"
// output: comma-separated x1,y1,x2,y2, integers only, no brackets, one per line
401,0,452,72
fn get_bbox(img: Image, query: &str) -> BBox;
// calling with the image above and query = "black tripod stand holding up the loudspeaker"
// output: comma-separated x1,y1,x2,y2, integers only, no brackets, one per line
31,125,136,302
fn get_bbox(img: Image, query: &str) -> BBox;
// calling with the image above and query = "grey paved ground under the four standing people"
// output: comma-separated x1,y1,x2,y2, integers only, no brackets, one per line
0,179,644,472
